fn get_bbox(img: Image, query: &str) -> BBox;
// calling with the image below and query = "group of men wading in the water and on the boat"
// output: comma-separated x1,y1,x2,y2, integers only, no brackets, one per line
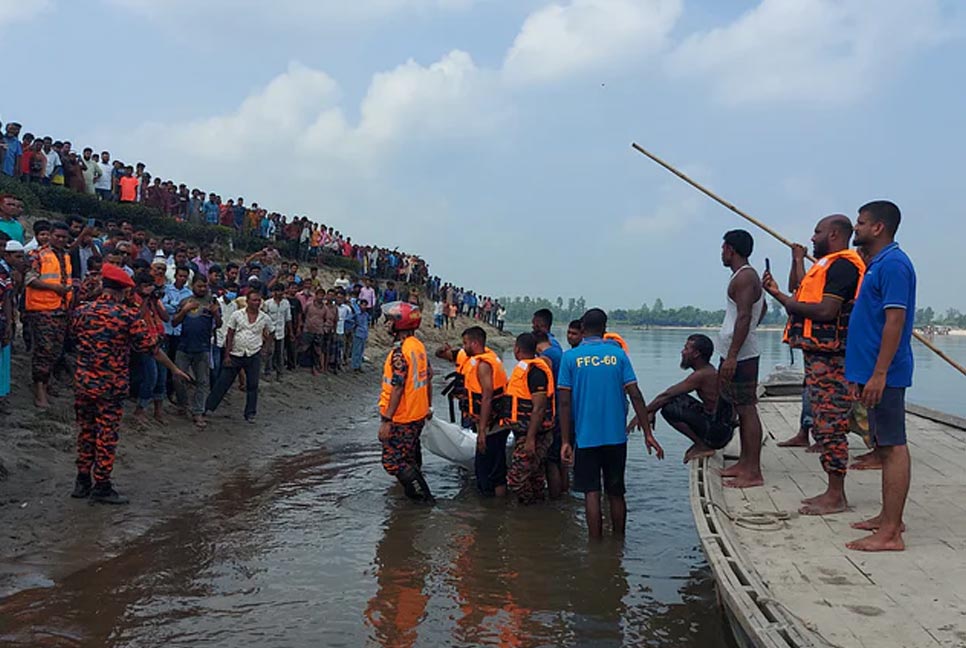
379,201,916,551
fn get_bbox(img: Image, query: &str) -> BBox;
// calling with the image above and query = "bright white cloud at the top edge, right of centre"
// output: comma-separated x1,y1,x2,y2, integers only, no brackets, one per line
504,0,682,81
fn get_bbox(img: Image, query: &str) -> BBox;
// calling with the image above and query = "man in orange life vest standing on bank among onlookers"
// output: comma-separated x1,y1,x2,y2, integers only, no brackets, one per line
24,223,74,408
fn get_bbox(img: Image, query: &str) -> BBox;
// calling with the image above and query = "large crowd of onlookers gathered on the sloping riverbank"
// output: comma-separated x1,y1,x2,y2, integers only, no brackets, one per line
0,115,510,502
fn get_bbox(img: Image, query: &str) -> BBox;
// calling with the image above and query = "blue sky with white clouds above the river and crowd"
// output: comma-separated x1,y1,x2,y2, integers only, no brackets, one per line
0,0,966,311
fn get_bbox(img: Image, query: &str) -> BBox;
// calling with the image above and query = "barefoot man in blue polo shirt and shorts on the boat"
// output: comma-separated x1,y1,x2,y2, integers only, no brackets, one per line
845,200,916,551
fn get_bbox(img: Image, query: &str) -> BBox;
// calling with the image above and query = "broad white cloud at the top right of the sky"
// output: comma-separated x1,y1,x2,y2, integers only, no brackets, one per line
669,0,943,104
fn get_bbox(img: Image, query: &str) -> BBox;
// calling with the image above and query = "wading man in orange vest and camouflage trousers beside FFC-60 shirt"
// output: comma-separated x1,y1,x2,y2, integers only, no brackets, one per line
506,333,555,504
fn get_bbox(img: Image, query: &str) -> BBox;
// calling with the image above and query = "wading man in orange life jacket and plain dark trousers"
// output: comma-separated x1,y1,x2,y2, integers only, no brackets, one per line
463,326,510,497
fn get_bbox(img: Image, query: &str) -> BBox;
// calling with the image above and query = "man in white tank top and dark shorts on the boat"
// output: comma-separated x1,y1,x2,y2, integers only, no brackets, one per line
718,230,765,488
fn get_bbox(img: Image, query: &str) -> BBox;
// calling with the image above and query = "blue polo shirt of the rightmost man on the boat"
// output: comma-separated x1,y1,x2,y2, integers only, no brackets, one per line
845,243,916,387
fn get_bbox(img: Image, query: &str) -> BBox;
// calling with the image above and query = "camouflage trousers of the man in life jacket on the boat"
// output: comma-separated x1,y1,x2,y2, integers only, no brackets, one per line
804,351,852,475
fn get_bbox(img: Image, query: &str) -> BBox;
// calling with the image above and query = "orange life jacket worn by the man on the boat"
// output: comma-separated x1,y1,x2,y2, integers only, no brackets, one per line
783,249,865,353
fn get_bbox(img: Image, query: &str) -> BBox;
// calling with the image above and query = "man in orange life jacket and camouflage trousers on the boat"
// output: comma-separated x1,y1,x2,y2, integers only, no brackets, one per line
762,214,865,515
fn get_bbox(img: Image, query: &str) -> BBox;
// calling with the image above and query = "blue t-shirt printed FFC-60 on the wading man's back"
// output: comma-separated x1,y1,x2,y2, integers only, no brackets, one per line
557,337,637,448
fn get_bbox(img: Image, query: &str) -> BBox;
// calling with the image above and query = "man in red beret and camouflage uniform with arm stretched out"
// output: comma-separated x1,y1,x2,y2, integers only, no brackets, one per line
71,264,190,504
